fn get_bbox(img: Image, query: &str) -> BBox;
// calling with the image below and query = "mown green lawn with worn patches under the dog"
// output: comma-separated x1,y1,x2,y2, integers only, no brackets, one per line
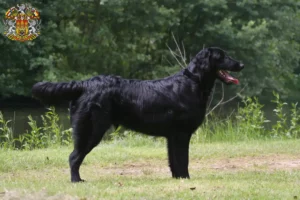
0,139,300,200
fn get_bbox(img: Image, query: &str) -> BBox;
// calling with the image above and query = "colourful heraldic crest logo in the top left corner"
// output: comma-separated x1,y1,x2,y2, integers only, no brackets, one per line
3,4,41,42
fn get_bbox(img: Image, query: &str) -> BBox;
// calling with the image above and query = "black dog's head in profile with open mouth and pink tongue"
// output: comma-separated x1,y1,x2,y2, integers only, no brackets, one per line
196,47,244,84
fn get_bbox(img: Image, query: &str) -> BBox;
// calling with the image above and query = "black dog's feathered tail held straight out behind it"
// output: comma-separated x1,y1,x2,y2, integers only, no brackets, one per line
32,81,84,105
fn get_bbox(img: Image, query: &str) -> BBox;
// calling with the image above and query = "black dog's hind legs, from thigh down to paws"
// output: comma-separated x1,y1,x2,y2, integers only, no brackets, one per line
69,105,111,182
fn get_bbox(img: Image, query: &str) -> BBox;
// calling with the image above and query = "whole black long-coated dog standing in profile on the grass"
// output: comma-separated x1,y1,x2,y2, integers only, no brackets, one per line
32,48,244,182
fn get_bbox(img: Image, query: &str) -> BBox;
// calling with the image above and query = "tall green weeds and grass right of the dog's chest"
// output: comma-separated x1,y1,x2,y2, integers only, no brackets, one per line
194,92,300,143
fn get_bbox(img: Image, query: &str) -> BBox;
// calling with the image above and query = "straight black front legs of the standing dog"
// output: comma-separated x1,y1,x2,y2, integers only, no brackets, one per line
168,134,192,178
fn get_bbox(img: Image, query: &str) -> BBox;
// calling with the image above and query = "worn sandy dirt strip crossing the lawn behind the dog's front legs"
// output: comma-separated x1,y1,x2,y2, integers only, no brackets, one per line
88,154,300,176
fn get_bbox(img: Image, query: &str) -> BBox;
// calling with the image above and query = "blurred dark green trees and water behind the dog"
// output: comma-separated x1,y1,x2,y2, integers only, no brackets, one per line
0,0,300,136
